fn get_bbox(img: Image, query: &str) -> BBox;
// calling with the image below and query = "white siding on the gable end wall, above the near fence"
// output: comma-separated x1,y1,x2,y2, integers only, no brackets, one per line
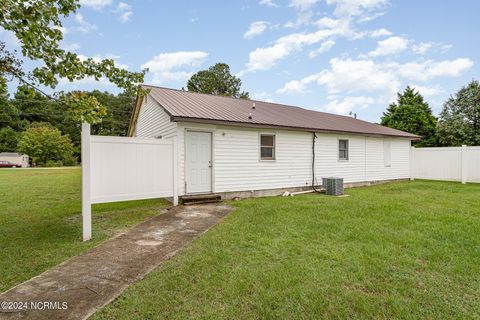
134,95,177,139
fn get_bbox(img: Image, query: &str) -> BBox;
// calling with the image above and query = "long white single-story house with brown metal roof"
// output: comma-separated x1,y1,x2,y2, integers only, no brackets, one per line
128,86,420,198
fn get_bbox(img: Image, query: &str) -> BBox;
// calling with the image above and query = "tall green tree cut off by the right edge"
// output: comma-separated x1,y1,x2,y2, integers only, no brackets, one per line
437,80,480,146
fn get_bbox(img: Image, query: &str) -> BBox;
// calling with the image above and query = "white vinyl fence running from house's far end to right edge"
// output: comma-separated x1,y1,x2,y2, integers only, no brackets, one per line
410,146,480,183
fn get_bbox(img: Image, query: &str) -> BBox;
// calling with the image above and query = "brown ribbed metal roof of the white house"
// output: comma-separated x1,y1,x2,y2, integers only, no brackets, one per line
143,85,420,139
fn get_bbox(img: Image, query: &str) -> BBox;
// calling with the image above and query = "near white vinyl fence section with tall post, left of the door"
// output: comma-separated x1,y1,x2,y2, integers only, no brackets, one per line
82,124,178,240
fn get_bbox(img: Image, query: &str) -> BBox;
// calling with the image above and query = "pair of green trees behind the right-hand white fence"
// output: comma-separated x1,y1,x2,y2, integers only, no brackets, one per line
381,80,480,147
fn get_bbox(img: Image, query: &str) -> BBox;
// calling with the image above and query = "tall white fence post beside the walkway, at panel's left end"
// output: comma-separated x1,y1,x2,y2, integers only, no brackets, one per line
81,122,92,241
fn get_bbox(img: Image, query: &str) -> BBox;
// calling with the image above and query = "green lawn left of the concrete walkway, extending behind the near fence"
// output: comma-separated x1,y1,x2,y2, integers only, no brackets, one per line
0,168,167,292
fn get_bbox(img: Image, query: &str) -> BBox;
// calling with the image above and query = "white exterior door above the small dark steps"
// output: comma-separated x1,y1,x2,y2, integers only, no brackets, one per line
185,131,212,193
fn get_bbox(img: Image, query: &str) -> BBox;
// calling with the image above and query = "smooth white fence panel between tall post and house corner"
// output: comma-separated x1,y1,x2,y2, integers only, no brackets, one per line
91,136,174,203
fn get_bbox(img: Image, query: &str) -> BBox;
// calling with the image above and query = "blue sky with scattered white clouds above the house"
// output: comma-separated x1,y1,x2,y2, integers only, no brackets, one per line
0,0,480,122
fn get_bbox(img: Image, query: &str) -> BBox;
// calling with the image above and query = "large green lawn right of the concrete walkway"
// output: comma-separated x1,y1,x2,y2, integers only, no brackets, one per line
94,181,480,319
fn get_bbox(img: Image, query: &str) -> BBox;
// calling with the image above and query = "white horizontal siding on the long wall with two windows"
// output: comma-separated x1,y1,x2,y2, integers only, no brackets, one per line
178,123,410,194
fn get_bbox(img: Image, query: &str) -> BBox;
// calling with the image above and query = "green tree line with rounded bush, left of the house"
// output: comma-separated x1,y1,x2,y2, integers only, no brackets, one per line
0,85,135,166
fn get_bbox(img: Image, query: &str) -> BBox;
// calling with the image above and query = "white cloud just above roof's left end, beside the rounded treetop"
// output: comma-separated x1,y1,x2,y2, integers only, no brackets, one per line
142,51,208,84
